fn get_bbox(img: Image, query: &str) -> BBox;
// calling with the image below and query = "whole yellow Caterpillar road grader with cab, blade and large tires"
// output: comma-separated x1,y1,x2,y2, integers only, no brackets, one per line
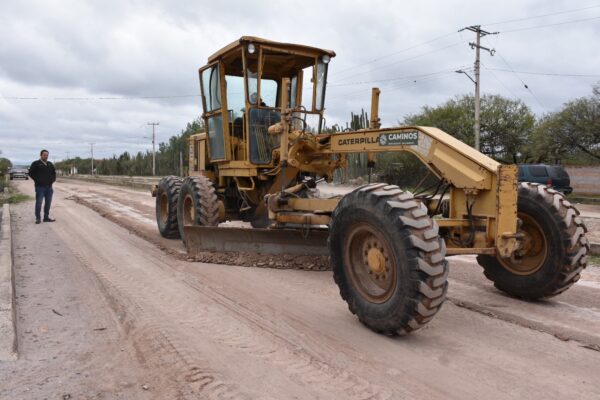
153,36,589,335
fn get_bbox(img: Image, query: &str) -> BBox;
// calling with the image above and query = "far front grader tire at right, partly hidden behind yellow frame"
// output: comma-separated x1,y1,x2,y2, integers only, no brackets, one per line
477,182,590,300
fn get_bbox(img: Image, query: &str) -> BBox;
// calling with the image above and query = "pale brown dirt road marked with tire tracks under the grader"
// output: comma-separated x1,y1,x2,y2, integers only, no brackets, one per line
0,181,600,399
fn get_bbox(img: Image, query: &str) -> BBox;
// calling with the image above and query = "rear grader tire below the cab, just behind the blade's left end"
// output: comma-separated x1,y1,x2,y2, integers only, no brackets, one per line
177,175,219,240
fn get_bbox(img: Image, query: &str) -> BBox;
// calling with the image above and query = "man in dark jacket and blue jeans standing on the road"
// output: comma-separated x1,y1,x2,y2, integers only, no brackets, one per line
29,150,56,224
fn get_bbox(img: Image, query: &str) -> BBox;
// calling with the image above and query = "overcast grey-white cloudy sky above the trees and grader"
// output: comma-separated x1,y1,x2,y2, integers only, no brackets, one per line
0,0,600,164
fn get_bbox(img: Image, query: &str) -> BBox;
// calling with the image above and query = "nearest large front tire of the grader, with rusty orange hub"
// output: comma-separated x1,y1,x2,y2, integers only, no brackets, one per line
328,184,448,335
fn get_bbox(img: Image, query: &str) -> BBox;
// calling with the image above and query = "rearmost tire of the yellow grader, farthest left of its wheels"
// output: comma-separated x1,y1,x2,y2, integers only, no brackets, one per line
156,176,181,239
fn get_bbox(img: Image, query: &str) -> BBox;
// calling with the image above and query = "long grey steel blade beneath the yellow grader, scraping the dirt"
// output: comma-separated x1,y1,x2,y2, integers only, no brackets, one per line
183,225,329,256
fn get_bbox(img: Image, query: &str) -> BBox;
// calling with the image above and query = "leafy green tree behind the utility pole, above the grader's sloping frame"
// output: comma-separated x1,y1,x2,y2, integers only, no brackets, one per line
404,95,535,163
